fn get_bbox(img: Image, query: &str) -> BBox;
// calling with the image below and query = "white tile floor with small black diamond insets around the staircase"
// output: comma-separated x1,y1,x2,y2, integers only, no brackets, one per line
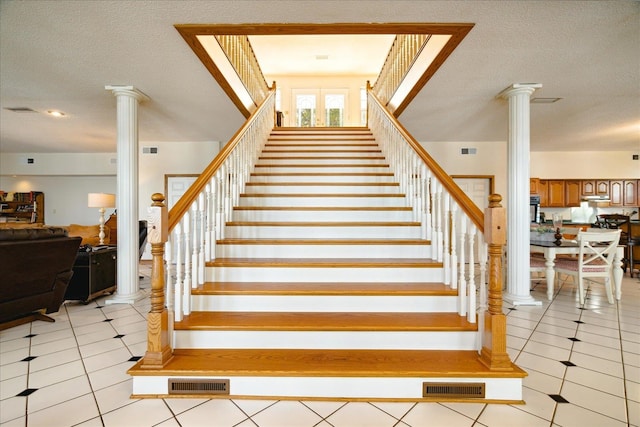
0,264,640,427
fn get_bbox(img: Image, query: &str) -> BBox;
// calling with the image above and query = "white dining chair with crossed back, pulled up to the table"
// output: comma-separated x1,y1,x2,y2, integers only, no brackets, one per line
554,229,620,305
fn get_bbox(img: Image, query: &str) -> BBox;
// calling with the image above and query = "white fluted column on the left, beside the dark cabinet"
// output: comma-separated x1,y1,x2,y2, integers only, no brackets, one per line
105,86,148,304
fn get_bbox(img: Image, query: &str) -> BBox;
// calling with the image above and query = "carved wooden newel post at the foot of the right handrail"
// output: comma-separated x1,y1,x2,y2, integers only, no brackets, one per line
480,194,513,371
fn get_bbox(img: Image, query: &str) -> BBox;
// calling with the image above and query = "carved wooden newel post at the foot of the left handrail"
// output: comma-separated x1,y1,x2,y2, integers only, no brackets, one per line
142,193,173,368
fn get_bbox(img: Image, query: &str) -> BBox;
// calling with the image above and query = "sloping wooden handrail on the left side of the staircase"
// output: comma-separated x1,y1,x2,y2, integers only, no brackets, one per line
169,88,276,232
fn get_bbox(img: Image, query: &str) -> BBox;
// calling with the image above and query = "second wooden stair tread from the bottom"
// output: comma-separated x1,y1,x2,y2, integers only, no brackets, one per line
174,311,478,332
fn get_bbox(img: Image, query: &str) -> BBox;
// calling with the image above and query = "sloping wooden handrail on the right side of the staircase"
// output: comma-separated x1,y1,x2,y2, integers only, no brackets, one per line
368,87,484,233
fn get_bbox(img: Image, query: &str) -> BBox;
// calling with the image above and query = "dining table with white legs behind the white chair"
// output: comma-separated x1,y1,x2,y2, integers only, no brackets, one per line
530,239,624,300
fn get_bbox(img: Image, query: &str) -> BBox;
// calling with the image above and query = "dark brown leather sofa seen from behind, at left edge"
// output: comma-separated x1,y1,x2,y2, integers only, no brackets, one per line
0,227,82,330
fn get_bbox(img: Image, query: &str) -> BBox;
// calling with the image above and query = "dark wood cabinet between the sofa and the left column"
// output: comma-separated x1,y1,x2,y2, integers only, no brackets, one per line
64,247,118,302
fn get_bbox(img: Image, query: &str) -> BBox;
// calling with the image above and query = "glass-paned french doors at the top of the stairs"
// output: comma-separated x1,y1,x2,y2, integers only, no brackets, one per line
291,89,349,127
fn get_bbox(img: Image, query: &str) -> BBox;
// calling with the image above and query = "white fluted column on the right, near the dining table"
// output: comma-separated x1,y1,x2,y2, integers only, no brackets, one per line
498,83,542,305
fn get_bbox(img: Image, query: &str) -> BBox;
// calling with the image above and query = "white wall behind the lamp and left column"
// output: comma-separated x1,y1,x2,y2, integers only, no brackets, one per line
0,141,220,225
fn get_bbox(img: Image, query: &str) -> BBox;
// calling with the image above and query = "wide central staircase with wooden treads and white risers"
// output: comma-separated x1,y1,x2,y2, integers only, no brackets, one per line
129,128,526,403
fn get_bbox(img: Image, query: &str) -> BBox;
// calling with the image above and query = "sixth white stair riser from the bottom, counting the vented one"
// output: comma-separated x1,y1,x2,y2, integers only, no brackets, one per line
224,225,420,239
